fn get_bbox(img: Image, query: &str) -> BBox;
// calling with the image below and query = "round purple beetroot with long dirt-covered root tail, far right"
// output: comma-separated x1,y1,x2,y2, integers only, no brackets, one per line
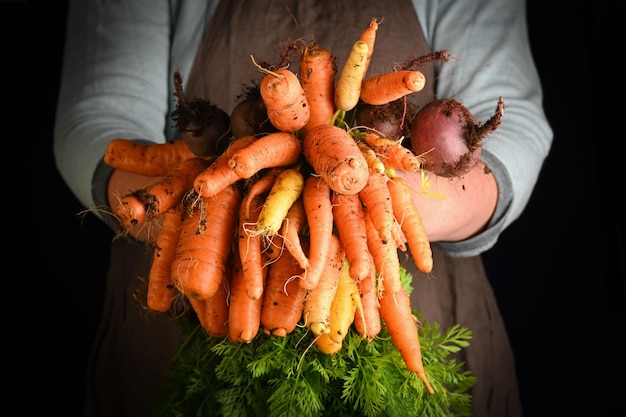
410,97,504,177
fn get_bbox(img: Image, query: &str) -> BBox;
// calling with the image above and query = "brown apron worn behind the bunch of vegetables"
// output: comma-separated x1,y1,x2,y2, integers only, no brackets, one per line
86,0,521,417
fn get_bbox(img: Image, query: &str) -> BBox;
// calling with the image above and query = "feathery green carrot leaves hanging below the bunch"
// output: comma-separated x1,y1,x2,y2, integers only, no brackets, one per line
156,316,475,417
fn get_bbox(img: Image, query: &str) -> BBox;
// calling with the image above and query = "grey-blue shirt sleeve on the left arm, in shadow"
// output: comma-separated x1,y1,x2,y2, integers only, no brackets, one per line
54,0,171,211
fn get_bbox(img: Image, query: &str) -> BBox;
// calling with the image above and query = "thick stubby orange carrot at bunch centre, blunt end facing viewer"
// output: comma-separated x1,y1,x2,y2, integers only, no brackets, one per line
303,125,369,194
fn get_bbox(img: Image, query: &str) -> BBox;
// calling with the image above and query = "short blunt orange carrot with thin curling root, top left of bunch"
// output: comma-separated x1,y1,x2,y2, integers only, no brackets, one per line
259,69,311,132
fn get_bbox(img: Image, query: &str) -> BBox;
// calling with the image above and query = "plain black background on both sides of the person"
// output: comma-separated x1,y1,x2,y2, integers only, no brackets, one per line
7,0,626,417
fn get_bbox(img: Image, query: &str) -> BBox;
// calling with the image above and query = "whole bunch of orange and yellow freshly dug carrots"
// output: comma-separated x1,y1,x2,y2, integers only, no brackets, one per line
104,19,434,393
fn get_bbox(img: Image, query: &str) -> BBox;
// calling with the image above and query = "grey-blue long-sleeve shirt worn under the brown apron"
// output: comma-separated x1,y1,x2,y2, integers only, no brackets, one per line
54,0,552,256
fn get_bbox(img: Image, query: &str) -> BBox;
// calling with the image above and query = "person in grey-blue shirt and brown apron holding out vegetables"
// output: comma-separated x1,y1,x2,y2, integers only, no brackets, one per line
54,0,552,417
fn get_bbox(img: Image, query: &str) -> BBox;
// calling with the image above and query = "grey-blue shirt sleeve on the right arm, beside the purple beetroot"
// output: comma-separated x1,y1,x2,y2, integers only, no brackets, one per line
414,0,553,256
